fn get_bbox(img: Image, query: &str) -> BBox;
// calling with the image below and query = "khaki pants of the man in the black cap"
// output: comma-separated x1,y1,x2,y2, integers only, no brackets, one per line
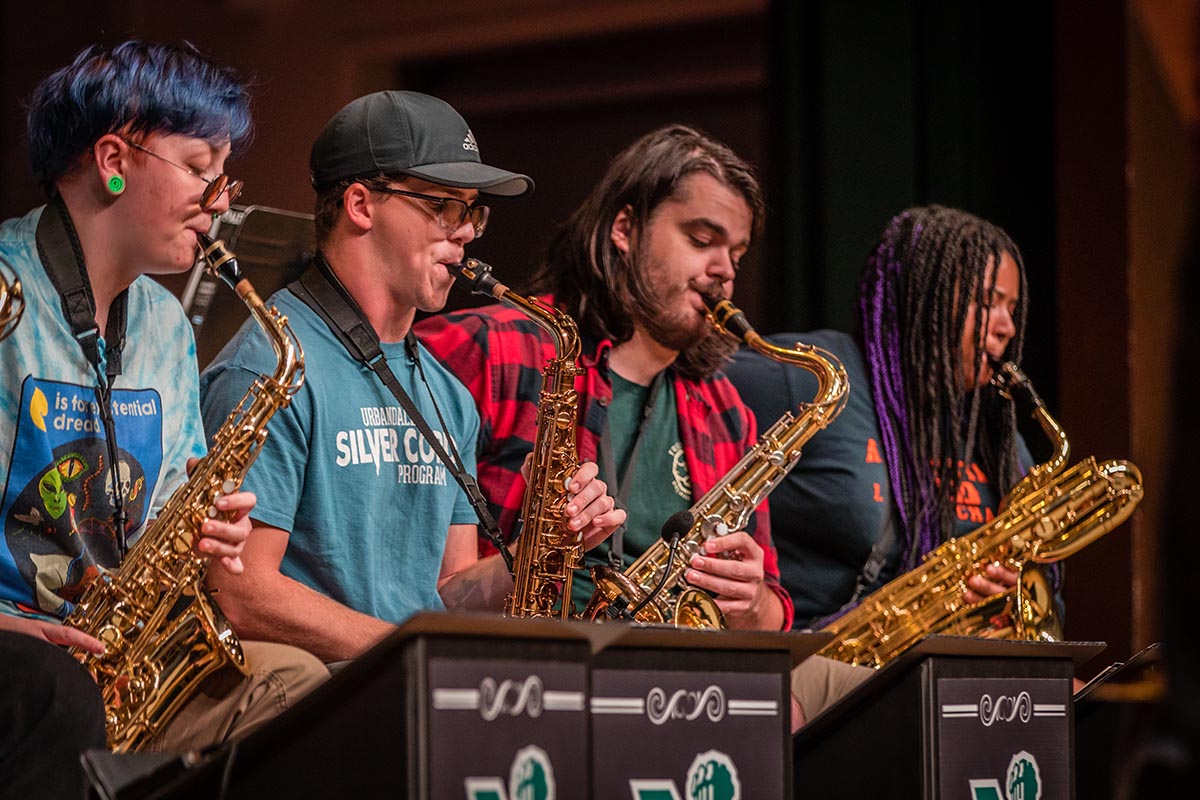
146,642,329,752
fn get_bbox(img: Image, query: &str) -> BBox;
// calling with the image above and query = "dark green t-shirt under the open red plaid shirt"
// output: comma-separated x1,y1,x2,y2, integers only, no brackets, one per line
571,372,692,610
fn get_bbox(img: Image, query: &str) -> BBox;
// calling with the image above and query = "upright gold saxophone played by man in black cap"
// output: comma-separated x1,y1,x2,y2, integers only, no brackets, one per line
450,258,583,619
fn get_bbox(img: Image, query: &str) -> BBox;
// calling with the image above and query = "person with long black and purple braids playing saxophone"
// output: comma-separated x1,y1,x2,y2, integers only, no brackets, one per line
726,205,1033,628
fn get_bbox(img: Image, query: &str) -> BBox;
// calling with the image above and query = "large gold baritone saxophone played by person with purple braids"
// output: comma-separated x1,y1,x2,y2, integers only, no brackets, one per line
820,362,1142,667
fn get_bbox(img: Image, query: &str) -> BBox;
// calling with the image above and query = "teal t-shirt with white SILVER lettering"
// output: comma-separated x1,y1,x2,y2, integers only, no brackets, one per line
200,289,479,622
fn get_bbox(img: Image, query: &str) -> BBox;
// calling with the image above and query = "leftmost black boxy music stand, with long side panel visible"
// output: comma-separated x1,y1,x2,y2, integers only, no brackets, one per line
91,613,590,800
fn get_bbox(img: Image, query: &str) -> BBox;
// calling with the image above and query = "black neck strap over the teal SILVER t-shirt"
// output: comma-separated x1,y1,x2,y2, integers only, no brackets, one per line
288,253,512,572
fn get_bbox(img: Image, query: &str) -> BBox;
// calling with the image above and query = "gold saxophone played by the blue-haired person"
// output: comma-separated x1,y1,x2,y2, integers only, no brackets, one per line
65,235,304,752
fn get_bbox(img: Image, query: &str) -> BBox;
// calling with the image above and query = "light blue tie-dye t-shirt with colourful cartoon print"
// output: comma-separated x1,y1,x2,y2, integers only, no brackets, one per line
0,209,204,616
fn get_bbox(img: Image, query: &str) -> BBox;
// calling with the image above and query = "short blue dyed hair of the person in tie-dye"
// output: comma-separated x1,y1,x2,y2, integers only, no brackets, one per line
26,41,252,194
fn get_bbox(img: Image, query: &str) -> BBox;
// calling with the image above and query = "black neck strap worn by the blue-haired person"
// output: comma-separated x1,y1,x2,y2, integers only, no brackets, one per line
35,194,130,558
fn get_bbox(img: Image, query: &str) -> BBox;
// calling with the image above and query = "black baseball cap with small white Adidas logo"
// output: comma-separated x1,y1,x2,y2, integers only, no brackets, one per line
308,90,533,197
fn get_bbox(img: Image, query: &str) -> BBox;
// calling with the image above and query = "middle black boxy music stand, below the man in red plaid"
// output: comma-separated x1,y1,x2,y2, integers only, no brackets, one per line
590,625,832,800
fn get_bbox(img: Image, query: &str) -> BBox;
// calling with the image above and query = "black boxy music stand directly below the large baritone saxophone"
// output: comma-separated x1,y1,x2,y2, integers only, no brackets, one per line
793,636,1104,800
